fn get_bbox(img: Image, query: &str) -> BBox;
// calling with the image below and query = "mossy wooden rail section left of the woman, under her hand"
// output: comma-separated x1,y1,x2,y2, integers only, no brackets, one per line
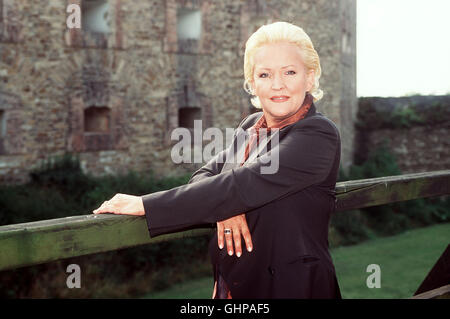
0,214,212,270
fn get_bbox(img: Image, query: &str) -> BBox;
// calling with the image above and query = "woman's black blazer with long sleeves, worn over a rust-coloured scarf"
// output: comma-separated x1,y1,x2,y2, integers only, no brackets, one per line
142,104,341,299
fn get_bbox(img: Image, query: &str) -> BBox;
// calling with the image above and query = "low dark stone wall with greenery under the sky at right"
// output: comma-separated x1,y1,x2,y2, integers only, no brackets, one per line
355,96,450,173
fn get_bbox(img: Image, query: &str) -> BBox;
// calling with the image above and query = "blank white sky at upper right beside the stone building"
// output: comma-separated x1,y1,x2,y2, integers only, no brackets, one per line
356,0,450,96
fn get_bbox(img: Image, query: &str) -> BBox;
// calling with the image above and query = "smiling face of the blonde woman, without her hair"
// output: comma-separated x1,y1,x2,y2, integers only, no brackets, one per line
250,42,314,127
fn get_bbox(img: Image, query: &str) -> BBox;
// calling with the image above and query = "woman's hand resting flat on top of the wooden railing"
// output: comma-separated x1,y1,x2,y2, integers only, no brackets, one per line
93,194,145,216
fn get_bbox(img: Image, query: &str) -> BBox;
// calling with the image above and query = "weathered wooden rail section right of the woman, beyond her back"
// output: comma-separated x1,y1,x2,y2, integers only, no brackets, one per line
336,170,450,212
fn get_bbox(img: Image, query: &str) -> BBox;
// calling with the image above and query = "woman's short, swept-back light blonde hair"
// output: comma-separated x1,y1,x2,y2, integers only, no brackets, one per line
244,21,323,108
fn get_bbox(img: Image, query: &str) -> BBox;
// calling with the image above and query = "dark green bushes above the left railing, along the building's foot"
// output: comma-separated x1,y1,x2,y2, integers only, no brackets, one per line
0,154,190,225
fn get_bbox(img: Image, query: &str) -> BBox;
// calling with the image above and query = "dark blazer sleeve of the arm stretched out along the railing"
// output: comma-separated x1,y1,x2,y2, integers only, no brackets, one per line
142,118,339,237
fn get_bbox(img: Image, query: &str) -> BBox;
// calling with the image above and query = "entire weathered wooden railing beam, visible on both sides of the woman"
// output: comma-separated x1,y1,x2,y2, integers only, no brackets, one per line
0,170,450,270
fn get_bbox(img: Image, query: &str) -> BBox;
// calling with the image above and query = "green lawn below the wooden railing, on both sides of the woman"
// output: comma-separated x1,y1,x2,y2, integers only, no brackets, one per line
143,223,450,299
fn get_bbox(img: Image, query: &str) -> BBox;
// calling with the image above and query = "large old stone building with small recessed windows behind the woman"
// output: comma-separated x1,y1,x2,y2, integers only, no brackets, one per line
0,0,357,183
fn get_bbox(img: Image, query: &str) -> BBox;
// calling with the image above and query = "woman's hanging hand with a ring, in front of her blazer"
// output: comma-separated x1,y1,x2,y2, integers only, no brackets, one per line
217,214,253,257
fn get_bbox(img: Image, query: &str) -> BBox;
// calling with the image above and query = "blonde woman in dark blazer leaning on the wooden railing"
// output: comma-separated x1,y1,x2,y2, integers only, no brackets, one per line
94,22,340,299
